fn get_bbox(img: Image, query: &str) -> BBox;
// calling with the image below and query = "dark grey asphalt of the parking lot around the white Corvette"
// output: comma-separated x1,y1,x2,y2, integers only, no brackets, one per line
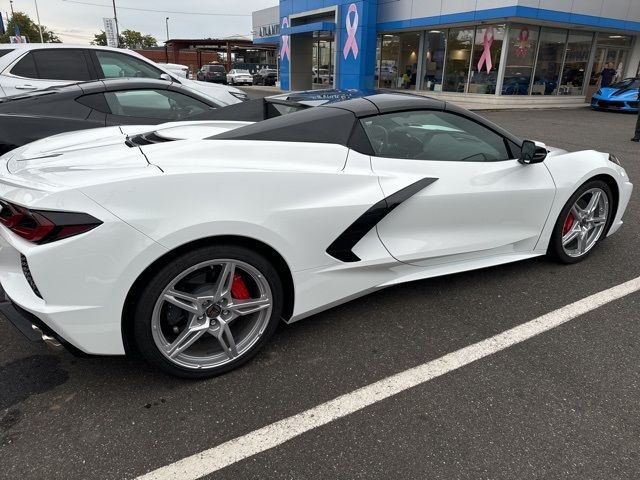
0,102,640,480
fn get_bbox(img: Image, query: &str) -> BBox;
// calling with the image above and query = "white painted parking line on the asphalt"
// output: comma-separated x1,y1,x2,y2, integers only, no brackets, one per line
137,277,640,480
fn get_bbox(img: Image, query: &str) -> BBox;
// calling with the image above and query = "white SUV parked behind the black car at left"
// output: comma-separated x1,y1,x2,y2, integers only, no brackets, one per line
0,43,248,105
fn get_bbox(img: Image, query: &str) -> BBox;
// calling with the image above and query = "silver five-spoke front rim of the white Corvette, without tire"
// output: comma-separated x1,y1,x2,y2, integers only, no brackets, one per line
562,188,609,258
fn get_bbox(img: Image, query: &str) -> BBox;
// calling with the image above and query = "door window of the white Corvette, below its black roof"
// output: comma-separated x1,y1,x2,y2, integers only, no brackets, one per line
361,110,513,162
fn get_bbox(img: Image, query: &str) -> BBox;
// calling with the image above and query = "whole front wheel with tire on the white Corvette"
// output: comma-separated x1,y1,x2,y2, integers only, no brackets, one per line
548,180,613,263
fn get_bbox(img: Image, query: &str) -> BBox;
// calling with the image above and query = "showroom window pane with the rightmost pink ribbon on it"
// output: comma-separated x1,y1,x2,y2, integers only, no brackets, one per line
502,25,545,95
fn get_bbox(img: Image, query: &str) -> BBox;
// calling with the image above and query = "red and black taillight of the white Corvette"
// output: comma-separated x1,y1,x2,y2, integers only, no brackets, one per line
0,200,102,244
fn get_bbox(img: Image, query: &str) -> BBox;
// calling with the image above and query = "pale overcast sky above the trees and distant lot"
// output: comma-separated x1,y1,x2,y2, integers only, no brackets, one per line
0,0,278,45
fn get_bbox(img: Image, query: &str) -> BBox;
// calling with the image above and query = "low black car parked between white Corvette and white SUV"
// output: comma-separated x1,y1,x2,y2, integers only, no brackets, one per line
0,79,335,154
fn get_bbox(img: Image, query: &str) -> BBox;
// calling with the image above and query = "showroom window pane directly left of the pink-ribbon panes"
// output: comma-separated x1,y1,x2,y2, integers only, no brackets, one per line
442,28,474,92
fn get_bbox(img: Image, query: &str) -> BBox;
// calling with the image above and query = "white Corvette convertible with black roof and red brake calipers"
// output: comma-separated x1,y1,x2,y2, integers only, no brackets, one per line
0,94,632,377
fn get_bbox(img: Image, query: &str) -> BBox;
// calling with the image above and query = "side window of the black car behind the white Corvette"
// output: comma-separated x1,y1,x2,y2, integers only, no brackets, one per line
104,90,211,121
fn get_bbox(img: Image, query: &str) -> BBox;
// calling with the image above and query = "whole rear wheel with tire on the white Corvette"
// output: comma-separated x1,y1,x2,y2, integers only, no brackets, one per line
134,245,283,378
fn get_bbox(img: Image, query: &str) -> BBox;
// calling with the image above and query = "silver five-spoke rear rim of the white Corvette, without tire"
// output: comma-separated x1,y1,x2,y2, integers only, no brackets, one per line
151,259,273,369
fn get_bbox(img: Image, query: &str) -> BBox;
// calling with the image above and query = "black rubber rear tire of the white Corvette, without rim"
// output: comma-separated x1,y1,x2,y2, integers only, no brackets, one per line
133,244,284,379
